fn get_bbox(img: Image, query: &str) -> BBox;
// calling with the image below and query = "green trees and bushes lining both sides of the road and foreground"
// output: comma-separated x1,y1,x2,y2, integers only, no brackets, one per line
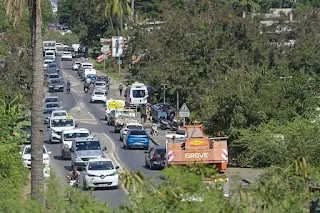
0,0,320,213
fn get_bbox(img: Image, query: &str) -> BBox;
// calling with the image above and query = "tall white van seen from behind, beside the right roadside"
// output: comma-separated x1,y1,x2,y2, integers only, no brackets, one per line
125,82,149,107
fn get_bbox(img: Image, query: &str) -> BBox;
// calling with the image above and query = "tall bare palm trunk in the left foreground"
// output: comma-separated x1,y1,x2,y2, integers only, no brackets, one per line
31,0,44,203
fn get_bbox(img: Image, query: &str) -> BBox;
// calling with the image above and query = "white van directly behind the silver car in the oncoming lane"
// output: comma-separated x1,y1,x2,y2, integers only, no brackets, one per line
60,128,91,159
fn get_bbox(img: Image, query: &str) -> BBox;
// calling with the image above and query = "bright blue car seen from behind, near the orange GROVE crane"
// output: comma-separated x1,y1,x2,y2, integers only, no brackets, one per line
123,129,149,150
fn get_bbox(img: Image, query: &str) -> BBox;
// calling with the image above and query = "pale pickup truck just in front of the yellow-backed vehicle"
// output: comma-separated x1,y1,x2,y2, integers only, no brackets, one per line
114,109,139,133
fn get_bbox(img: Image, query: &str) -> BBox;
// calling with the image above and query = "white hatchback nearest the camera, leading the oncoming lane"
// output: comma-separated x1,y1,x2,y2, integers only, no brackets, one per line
83,158,119,188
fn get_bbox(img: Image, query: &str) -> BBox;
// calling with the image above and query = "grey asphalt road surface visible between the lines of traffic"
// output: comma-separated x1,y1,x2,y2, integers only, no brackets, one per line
44,57,159,207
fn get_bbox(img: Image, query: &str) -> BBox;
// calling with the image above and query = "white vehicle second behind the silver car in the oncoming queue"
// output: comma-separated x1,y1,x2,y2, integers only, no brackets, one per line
48,115,76,143
